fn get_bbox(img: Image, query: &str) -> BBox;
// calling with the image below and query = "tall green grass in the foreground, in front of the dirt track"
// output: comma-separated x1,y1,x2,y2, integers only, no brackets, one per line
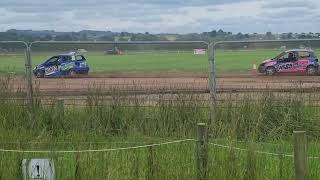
0,79,320,180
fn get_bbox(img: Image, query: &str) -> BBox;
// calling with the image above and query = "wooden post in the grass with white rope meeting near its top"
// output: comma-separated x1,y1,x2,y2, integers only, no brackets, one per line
197,123,208,180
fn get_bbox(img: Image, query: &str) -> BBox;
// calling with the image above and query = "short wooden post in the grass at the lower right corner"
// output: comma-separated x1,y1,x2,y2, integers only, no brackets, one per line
293,131,308,180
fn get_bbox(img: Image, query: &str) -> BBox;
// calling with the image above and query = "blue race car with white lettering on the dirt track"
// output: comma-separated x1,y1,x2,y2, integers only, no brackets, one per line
33,54,89,78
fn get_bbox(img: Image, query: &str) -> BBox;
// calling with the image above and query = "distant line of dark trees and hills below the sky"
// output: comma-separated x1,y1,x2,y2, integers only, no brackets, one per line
0,29,320,42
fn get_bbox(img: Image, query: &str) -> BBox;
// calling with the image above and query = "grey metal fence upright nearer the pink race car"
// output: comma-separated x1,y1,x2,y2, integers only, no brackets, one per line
208,43,216,100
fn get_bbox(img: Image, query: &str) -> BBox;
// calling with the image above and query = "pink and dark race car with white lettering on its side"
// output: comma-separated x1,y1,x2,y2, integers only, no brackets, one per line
258,49,319,76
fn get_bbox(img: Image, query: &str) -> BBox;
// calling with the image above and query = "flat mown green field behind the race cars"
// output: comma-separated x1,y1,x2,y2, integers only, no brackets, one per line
0,50,320,74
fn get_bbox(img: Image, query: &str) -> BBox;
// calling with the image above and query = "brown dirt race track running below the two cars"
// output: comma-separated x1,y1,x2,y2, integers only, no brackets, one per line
7,74,320,96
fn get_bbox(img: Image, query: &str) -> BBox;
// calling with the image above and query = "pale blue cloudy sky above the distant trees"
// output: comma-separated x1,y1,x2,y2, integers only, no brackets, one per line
0,0,320,34
